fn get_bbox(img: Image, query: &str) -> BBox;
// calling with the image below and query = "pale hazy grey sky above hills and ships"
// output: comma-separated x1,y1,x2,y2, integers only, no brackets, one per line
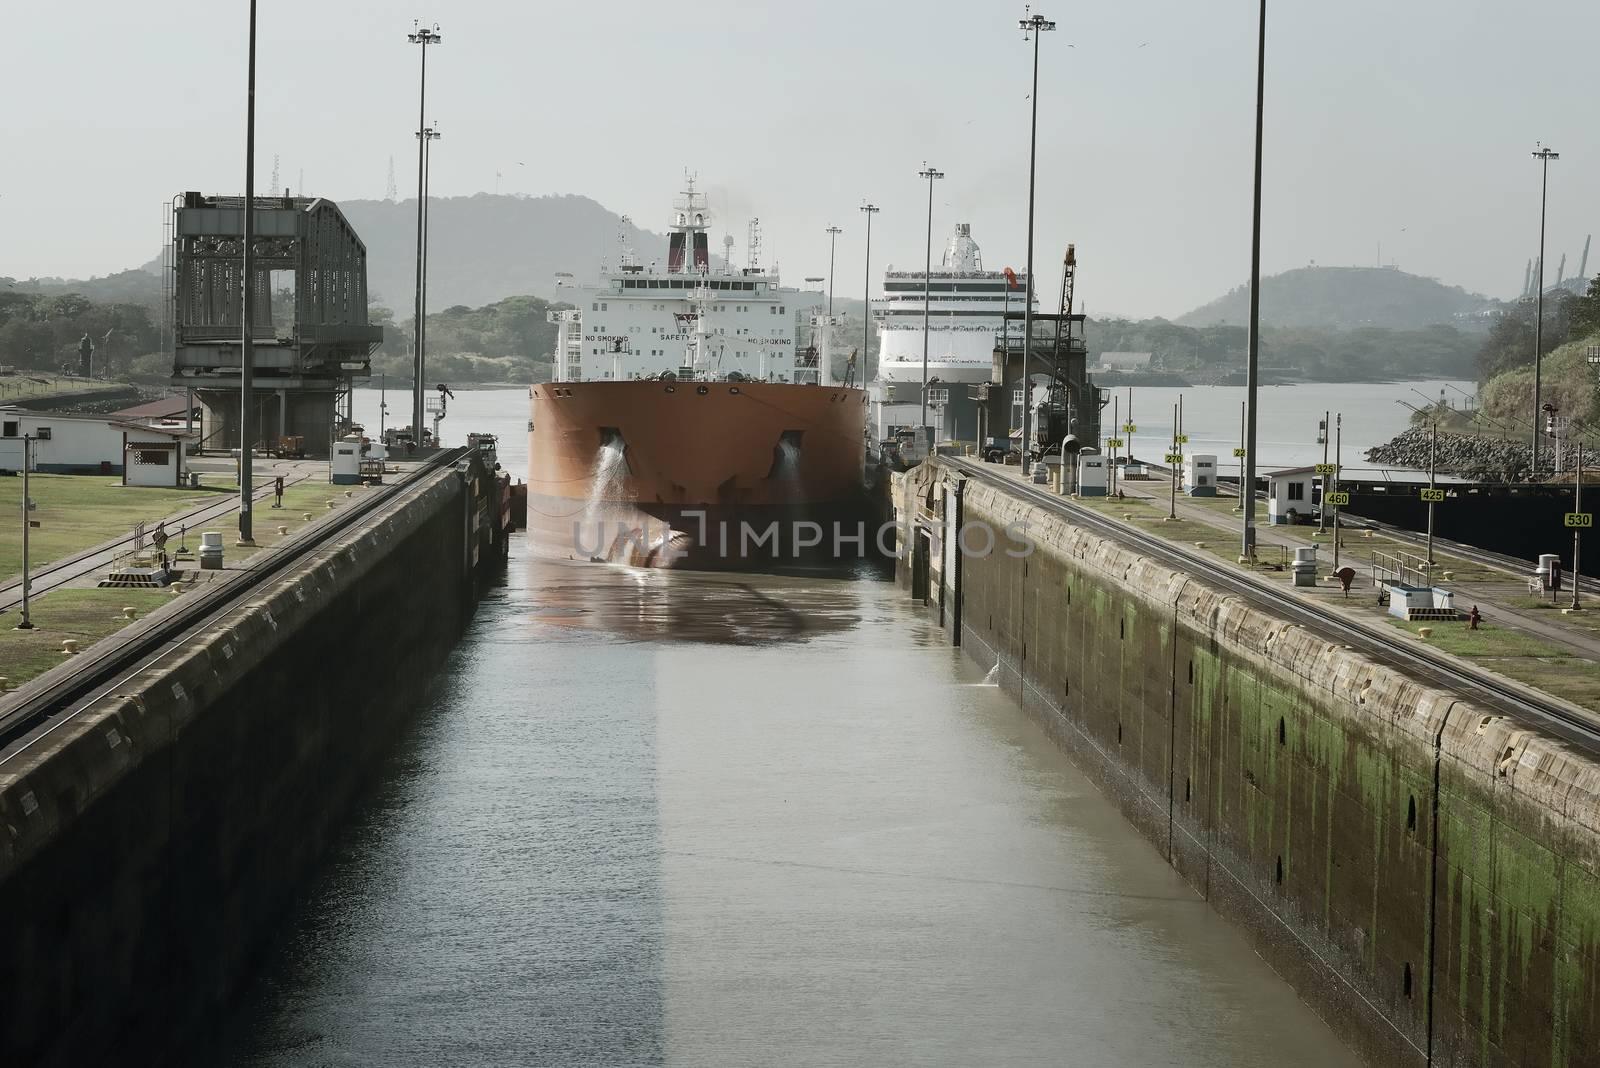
0,0,1600,315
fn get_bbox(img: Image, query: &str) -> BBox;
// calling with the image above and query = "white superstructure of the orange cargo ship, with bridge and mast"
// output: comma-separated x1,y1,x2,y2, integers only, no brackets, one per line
550,179,821,384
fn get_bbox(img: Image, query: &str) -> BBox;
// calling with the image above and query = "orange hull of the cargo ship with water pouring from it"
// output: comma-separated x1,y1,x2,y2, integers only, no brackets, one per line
528,381,867,566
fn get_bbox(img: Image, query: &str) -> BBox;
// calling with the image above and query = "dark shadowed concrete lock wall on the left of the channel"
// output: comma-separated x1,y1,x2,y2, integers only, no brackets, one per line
0,468,486,1065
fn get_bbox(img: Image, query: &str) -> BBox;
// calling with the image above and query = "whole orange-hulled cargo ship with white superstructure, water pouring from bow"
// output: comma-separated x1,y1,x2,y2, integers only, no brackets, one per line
528,179,867,568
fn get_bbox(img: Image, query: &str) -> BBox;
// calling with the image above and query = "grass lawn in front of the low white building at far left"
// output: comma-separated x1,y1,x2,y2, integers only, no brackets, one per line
0,475,227,579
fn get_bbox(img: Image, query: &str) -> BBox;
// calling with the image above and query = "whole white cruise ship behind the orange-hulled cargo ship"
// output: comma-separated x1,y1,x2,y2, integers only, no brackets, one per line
869,222,1038,441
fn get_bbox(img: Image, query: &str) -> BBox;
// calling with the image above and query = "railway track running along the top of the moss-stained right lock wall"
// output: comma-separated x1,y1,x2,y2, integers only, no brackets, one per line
941,457,1600,751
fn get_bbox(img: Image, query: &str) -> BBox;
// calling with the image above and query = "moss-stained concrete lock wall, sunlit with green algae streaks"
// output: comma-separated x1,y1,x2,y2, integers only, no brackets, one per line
898,465,1600,1068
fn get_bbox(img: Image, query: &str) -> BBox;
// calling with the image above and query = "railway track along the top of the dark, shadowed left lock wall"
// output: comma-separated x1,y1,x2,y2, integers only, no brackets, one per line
0,448,466,766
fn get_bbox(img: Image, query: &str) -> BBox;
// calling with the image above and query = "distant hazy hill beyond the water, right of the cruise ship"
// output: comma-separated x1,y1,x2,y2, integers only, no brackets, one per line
1176,267,1491,329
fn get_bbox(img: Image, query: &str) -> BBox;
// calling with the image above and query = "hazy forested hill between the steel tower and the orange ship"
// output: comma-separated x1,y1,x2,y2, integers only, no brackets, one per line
339,193,667,317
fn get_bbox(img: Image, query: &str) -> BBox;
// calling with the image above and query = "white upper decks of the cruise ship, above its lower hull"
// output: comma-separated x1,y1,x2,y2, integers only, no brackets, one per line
872,222,1037,393
